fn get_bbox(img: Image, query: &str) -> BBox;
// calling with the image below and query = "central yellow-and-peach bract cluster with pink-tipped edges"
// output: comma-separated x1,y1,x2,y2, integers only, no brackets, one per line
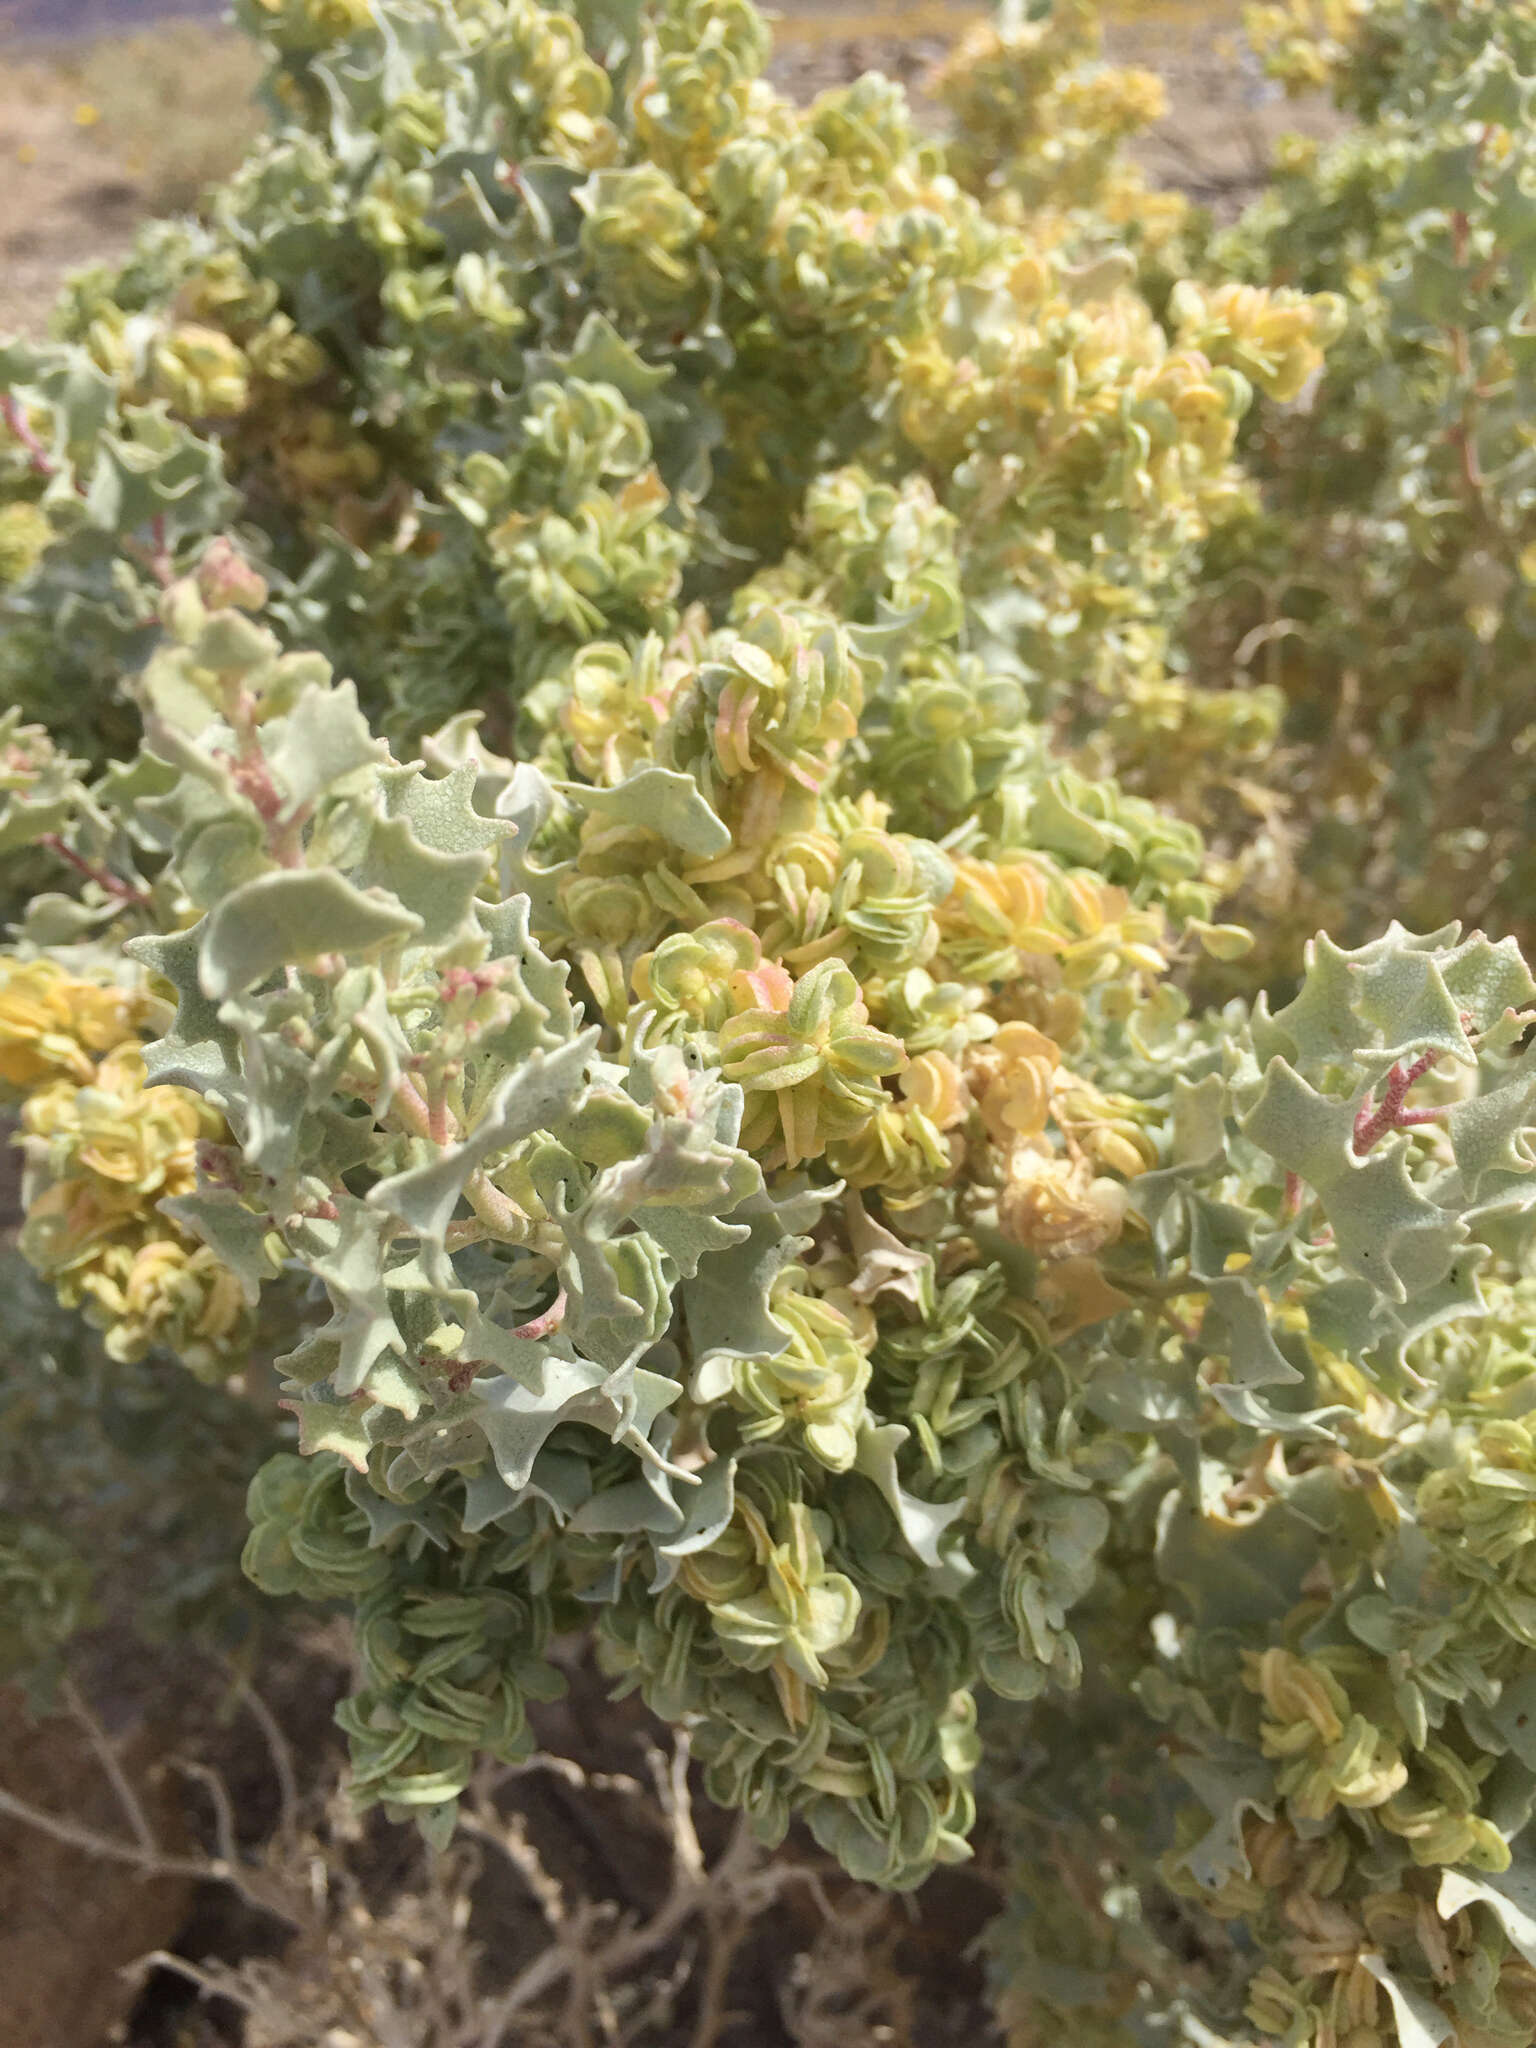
618,766,1165,1236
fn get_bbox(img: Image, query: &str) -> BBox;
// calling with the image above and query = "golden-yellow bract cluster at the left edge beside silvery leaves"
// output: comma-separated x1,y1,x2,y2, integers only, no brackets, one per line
0,958,250,1374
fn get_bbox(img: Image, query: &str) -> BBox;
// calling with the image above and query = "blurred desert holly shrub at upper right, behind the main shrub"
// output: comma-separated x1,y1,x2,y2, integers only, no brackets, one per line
1196,0,1536,966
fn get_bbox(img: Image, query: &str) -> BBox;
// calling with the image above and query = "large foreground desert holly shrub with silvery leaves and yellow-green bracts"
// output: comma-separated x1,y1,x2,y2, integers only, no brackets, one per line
0,0,1536,2048
